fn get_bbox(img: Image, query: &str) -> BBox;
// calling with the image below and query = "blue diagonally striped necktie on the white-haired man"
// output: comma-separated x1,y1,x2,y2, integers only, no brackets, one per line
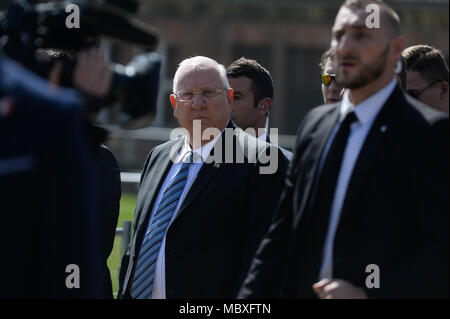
131,153,192,299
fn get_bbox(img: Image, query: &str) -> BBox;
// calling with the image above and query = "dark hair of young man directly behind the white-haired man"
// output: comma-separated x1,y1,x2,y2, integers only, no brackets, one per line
227,57,273,107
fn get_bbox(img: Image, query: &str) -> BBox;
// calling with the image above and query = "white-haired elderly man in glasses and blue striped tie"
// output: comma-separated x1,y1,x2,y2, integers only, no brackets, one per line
119,57,286,299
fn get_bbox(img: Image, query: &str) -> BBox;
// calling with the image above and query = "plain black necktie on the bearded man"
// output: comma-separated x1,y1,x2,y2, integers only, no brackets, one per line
308,111,358,280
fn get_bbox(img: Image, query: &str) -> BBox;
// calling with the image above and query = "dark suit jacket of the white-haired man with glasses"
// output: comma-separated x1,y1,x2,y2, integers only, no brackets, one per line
119,122,287,298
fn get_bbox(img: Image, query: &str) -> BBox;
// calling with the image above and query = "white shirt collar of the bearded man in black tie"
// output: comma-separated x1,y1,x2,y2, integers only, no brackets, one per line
340,78,397,124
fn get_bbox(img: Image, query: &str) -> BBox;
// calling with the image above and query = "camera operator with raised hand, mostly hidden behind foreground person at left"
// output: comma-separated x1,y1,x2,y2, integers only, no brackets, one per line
37,47,121,298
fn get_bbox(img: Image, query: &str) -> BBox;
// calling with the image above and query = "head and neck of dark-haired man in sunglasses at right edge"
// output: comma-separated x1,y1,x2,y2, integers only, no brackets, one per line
402,45,449,114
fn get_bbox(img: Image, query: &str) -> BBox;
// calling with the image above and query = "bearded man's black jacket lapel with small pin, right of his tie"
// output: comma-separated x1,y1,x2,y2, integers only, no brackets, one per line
341,86,405,224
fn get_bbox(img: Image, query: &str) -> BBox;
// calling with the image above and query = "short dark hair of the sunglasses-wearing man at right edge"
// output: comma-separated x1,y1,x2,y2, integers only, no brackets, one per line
402,44,448,83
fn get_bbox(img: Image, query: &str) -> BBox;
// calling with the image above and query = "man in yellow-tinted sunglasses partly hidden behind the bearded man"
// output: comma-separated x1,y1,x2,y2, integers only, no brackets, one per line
319,49,345,104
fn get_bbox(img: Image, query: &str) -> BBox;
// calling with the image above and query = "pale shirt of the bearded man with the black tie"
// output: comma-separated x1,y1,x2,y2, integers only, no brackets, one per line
319,79,397,280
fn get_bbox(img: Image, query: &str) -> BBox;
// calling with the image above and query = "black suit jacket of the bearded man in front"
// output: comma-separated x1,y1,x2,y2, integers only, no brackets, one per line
240,87,449,298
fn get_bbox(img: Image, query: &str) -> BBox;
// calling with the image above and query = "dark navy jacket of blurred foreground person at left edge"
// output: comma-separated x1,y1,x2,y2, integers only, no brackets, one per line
0,52,103,298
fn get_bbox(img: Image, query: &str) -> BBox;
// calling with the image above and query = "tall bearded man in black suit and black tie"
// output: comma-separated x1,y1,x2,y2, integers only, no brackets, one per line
240,0,449,299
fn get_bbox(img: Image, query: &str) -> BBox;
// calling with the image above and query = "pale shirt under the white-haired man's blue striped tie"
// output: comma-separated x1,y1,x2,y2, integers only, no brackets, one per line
147,130,223,299
